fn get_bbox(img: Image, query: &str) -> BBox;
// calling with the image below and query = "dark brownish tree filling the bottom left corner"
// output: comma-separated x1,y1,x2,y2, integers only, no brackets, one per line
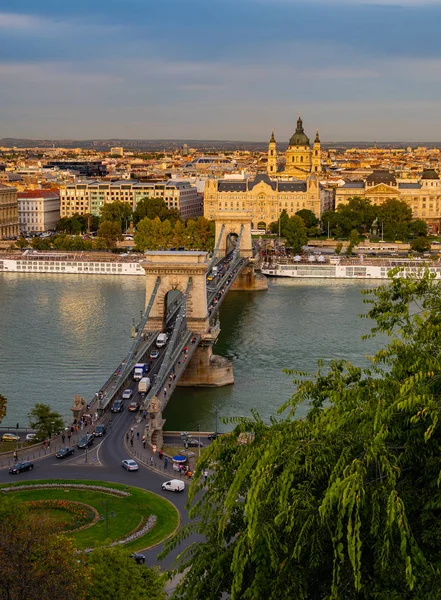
0,497,89,600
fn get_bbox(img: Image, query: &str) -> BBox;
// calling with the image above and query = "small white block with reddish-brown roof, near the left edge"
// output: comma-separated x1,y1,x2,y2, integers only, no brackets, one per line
17,190,60,233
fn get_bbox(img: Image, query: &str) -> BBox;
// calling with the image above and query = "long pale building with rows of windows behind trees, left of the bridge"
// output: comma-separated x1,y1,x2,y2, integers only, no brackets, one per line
60,180,203,219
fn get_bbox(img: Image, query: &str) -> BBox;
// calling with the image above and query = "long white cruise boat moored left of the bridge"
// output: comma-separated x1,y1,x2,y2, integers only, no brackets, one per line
0,250,145,276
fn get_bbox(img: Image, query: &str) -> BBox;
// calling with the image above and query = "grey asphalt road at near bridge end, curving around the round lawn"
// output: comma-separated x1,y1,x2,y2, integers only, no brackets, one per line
0,404,197,569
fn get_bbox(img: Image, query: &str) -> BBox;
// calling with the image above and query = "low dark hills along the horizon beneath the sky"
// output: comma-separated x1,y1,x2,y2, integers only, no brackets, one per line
0,138,441,152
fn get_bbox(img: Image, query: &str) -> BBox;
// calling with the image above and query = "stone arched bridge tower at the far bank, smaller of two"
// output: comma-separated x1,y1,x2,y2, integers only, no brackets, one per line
214,210,253,258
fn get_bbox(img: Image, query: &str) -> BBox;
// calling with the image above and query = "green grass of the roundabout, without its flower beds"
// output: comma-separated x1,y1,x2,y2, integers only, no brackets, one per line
0,480,179,550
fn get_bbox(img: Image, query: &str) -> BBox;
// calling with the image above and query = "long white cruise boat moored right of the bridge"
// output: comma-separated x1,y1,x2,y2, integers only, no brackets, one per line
261,256,441,279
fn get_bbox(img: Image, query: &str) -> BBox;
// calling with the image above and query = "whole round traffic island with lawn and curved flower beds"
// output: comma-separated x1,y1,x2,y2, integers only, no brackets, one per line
0,479,180,551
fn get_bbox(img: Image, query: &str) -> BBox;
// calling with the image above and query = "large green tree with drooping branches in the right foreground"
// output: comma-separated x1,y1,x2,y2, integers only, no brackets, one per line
167,271,441,600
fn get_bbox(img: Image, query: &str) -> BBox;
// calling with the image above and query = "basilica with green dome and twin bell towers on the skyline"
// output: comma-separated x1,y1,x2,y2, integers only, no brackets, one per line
267,117,321,179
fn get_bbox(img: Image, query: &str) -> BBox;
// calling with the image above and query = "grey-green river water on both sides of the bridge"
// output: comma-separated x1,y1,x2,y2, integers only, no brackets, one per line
0,273,380,431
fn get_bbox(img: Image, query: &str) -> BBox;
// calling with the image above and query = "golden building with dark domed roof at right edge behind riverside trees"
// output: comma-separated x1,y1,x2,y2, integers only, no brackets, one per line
335,169,441,232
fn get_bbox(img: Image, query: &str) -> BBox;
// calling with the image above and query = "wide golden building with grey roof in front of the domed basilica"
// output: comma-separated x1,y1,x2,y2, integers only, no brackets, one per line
204,173,334,229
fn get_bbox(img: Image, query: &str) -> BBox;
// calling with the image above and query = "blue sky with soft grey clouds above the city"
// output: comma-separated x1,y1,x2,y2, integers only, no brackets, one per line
0,0,441,141
